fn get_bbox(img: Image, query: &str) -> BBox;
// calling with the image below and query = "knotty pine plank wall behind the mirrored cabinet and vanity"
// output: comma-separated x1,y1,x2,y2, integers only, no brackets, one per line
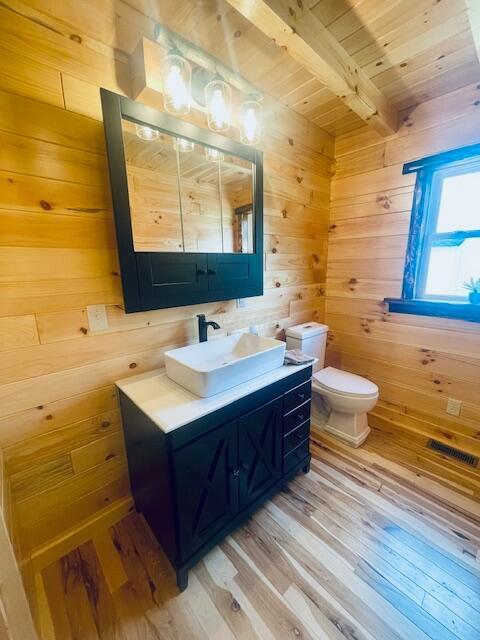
0,0,333,557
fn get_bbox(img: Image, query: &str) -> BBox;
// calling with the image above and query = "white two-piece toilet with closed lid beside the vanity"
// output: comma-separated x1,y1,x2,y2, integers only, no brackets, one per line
286,322,378,447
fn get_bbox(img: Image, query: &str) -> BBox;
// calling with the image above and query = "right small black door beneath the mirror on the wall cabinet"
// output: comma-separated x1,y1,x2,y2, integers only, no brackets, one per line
207,253,262,298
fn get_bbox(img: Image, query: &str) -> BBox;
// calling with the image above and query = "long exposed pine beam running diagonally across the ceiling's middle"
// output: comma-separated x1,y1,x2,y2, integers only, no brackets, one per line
227,0,398,136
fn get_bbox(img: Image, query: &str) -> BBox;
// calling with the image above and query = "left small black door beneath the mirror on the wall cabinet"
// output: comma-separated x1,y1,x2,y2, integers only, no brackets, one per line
135,253,208,309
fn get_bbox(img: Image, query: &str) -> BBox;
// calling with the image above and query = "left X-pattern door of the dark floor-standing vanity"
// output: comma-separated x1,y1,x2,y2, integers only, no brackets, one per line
173,422,238,559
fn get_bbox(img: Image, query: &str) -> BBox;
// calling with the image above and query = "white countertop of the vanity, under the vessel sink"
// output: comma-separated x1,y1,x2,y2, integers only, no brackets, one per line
116,364,312,433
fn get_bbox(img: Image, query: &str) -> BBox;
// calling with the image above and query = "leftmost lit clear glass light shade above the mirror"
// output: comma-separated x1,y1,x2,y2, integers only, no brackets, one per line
162,53,192,115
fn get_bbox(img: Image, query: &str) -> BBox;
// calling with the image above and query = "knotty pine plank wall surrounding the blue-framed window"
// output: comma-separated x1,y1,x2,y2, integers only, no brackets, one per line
326,78,480,455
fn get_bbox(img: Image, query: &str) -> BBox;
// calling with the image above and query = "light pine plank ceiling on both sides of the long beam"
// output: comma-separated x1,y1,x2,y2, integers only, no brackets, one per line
153,0,480,135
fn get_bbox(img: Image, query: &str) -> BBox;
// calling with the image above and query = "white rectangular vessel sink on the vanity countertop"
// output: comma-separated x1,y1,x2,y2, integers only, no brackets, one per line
165,333,285,398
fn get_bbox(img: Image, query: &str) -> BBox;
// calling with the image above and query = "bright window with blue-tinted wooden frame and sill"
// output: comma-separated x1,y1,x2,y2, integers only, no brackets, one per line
386,145,480,322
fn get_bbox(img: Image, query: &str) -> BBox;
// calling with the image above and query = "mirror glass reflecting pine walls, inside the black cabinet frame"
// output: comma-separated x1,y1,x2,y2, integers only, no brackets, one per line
122,118,255,253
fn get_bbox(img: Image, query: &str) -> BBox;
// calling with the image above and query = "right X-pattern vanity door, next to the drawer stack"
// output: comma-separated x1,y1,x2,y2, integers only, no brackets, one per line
238,397,283,509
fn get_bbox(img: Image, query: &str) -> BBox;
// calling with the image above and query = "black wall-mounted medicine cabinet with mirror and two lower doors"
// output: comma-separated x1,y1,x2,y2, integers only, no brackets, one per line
100,89,263,313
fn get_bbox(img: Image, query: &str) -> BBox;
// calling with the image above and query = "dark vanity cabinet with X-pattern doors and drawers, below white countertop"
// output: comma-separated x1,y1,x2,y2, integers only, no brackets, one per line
120,367,312,590
